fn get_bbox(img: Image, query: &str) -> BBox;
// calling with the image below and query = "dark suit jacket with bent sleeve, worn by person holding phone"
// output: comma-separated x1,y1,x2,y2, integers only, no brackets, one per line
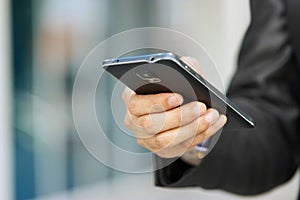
155,0,300,198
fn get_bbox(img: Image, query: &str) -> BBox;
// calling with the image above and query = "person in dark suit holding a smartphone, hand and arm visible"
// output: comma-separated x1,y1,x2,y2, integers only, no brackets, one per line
124,0,300,195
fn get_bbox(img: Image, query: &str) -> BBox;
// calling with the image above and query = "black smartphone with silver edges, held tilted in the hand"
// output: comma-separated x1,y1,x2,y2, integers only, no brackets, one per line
102,52,255,128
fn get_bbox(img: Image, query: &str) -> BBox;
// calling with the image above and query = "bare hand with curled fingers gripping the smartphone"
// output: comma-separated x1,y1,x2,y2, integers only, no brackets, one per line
123,88,227,158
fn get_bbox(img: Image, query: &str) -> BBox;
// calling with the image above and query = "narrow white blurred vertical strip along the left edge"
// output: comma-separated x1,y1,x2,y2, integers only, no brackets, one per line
0,0,13,200
